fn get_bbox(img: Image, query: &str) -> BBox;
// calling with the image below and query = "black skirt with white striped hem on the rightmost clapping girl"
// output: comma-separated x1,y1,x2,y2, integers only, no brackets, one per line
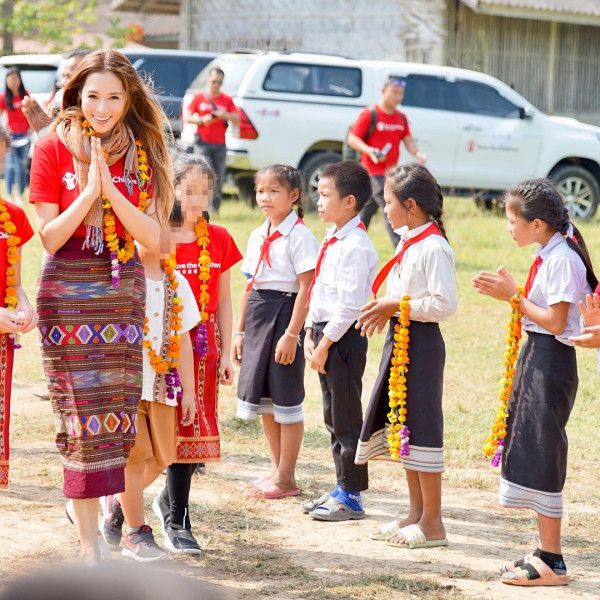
499,332,579,519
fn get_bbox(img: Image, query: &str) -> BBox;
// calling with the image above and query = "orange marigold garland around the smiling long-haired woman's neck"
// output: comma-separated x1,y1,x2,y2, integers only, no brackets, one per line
81,119,150,288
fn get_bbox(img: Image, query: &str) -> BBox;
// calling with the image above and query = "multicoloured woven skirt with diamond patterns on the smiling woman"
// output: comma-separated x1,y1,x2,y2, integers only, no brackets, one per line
37,239,146,499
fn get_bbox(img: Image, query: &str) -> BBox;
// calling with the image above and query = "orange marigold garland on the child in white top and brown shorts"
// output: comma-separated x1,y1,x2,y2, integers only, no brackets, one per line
144,256,183,400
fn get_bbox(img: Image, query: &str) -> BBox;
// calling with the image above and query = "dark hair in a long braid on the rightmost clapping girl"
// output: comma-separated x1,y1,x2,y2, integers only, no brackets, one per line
505,179,598,290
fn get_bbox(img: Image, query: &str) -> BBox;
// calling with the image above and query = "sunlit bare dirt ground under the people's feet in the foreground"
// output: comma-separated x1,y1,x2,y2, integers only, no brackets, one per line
0,386,600,600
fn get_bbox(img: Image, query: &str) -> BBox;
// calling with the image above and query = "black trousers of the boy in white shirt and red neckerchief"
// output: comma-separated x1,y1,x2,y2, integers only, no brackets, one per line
313,323,369,492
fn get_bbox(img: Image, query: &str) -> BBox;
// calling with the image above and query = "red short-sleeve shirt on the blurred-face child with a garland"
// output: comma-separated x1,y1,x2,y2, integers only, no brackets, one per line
176,224,242,313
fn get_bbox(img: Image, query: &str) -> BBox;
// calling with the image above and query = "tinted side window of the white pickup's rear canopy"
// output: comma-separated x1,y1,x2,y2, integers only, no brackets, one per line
263,63,362,98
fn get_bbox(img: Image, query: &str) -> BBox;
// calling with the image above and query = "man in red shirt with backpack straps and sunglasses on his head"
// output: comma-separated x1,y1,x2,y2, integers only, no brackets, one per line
348,75,427,247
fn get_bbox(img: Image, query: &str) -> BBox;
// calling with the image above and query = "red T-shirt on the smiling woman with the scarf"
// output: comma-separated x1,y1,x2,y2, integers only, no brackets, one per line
29,133,148,238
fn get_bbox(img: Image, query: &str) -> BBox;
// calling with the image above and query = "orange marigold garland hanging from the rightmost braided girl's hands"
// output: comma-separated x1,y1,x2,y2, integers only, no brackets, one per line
483,288,525,467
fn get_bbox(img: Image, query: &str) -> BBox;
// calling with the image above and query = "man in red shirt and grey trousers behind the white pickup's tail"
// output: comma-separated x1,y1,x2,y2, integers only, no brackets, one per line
184,67,239,212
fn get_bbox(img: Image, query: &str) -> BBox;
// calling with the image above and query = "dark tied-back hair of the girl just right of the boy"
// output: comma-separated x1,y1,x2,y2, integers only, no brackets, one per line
385,162,448,239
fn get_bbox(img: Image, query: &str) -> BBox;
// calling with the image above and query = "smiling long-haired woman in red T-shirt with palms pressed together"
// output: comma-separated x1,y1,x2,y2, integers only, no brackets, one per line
29,50,175,561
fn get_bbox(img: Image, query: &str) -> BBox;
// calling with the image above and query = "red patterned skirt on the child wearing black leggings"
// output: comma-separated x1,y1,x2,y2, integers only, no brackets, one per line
176,314,221,463
